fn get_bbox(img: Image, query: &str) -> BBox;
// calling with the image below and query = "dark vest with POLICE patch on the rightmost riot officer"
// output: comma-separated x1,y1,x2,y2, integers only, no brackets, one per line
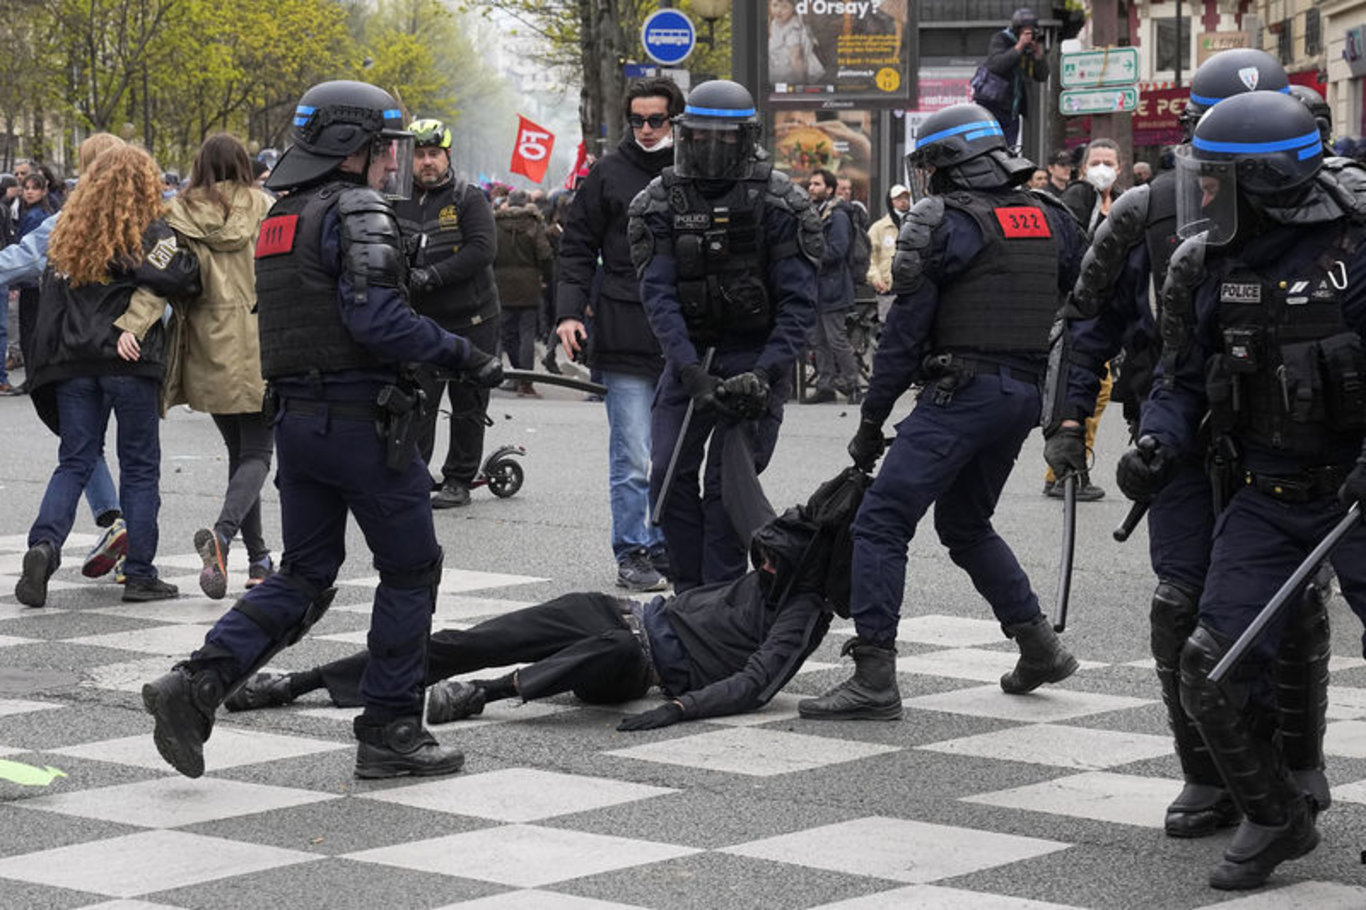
1205,230,1366,459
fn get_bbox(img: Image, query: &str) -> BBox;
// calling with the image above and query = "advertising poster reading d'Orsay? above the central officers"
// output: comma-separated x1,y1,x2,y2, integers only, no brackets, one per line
765,0,915,108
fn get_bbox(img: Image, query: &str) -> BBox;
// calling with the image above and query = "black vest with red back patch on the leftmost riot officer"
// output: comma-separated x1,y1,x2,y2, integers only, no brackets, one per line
255,183,384,380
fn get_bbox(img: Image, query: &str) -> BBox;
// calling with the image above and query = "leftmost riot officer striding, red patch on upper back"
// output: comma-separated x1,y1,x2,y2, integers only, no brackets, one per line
142,82,501,777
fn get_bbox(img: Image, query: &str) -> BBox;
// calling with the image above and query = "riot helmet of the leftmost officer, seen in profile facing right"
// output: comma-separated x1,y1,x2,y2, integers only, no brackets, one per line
265,79,413,198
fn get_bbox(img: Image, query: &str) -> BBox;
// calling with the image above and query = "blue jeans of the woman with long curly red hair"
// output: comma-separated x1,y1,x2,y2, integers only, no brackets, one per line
29,376,161,578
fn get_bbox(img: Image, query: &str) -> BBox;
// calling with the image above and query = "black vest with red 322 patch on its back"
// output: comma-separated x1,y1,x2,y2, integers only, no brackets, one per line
933,190,1059,354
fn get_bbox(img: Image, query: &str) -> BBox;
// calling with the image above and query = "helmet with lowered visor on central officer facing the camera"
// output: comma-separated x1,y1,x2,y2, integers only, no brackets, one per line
673,79,759,180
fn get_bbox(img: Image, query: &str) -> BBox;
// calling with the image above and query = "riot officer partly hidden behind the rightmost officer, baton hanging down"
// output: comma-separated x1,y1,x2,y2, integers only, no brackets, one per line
1044,48,1329,838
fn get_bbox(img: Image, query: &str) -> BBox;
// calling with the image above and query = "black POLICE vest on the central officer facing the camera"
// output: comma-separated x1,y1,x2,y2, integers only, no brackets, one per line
663,165,773,344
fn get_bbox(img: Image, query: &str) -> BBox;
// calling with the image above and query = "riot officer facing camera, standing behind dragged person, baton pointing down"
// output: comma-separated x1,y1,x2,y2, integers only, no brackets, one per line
627,79,824,592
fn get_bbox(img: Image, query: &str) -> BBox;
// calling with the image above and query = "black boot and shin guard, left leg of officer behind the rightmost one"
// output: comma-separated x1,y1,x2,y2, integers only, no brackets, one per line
1149,581,1242,838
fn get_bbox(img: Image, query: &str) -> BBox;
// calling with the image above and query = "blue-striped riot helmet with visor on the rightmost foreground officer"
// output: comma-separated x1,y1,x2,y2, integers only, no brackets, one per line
1176,92,1324,245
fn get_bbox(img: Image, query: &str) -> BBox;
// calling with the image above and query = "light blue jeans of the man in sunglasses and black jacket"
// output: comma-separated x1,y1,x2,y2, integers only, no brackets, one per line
602,372,664,562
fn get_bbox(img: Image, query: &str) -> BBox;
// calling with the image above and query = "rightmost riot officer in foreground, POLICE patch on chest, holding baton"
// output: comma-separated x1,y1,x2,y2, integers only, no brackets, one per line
1119,92,1366,890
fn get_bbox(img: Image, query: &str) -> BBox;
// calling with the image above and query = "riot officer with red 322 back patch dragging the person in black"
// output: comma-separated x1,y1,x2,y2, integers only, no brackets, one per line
798,104,1085,720
